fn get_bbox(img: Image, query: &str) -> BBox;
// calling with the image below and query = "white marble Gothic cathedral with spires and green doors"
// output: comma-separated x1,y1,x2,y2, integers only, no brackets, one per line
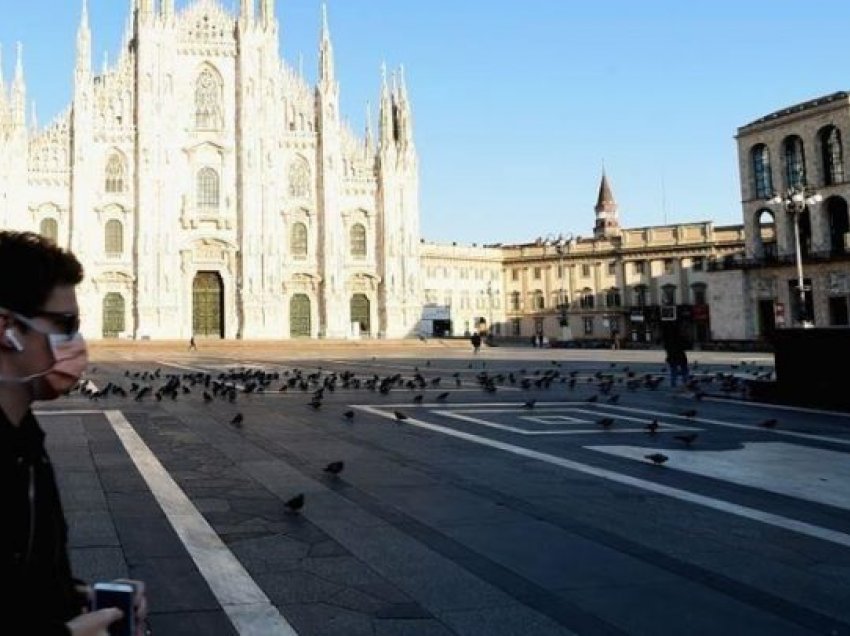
0,0,422,339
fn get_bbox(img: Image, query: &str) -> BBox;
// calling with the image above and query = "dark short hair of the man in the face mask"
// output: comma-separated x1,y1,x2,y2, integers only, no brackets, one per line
0,231,83,316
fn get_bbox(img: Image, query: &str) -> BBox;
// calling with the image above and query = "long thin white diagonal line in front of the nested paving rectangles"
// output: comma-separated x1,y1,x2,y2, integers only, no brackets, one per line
354,405,850,548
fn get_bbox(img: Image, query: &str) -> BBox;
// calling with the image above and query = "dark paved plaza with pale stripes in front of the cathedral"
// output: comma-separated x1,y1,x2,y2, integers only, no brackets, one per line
39,341,850,636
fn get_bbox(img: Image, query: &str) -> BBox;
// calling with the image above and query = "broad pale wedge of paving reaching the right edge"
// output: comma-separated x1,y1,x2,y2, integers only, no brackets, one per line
585,442,850,510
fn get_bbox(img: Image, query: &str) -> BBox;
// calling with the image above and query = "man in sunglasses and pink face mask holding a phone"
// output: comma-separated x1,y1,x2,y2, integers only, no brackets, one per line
0,232,147,636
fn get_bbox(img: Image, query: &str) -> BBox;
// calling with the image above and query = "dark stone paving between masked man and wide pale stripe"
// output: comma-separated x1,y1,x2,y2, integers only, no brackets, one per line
40,416,235,636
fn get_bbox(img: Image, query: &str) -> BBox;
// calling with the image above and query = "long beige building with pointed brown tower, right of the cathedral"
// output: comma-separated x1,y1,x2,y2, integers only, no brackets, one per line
494,174,744,345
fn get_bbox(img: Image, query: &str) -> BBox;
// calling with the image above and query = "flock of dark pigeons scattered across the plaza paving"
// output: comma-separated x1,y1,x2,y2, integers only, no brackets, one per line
76,361,778,513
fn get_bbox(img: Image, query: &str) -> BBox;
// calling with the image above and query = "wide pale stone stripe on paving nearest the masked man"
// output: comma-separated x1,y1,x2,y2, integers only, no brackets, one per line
104,411,298,636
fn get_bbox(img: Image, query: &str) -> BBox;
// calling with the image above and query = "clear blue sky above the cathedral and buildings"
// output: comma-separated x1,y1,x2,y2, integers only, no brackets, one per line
0,0,850,243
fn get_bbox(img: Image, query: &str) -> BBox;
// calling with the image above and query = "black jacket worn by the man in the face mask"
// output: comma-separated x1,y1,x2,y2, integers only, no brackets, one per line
0,409,84,636
